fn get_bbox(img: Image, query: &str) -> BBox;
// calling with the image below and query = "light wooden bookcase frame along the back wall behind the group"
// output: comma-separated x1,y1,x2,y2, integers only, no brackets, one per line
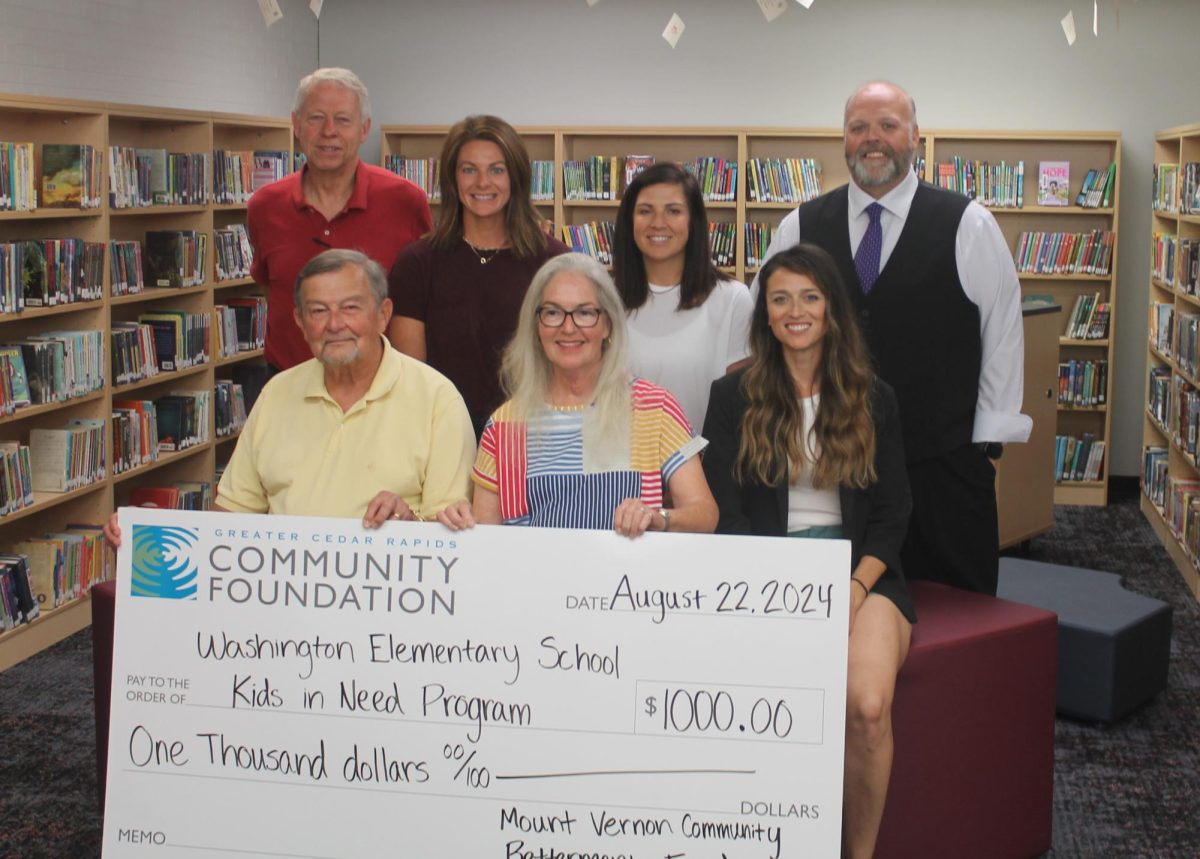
380,125,1121,505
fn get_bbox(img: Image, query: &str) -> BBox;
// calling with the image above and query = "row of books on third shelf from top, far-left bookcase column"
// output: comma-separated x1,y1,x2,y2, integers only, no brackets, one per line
0,331,104,408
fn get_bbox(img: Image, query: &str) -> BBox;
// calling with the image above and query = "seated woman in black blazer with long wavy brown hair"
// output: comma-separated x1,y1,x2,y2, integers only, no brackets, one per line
703,242,917,857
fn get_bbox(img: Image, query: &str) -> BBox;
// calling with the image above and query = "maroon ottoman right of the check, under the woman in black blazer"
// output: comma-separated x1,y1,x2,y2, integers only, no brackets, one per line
876,582,1058,859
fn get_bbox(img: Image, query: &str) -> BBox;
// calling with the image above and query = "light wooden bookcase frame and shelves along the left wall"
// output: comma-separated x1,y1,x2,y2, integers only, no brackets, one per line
0,95,292,671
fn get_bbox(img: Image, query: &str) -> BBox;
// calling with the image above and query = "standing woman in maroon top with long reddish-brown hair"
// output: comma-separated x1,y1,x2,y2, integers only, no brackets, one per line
388,116,570,438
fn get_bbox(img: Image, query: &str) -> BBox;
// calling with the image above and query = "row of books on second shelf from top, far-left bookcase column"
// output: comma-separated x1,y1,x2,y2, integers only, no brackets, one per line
0,239,104,313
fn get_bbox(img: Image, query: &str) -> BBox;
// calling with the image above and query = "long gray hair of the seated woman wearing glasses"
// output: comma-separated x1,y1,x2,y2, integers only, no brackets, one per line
500,253,630,467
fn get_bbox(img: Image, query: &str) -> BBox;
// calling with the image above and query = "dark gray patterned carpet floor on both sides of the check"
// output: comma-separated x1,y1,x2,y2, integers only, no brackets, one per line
0,497,1200,859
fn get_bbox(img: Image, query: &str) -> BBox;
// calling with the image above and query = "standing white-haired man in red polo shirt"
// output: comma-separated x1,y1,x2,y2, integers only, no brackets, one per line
246,68,433,372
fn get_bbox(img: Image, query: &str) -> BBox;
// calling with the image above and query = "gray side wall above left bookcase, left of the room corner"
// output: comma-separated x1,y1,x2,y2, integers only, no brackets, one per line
0,0,317,115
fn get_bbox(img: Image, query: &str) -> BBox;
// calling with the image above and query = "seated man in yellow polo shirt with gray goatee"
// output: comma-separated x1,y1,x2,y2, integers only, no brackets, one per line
216,244,475,527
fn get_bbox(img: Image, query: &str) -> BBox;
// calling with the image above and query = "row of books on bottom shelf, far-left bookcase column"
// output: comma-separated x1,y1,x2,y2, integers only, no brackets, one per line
0,524,116,630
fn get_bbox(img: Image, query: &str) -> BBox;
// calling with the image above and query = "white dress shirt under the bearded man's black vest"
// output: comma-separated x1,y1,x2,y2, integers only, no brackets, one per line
750,172,1033,441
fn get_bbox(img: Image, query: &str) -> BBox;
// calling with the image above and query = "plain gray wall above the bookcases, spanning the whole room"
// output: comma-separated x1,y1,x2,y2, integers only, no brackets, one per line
0,0,1200,474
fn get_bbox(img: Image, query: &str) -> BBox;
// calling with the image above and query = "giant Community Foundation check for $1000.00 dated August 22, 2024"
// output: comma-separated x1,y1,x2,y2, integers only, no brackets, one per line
103,509,850,859
